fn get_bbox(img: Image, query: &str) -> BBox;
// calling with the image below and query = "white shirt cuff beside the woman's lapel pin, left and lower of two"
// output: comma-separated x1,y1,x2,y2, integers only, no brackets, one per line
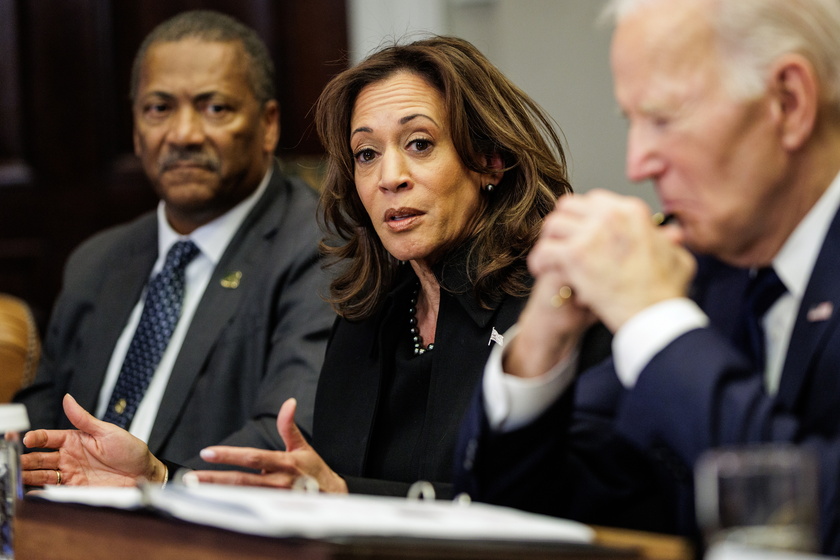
482,325,580,432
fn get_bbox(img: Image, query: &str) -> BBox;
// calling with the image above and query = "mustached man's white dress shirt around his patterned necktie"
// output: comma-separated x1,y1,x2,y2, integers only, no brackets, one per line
96,167,272,441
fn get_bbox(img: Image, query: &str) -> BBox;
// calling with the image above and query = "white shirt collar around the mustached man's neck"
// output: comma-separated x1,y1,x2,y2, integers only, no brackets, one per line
157,166,274,266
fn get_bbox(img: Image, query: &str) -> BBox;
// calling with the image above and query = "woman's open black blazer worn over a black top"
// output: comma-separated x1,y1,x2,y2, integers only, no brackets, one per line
313,265,525,497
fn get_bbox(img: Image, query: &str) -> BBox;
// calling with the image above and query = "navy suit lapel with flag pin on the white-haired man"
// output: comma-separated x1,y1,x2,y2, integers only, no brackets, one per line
778,208,840,410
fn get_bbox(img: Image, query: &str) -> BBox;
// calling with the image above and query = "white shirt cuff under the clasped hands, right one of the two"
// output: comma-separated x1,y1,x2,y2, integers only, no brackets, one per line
612,298,709,389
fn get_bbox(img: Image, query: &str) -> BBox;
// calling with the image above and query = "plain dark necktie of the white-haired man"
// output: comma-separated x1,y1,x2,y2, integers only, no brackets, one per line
734,266,787,371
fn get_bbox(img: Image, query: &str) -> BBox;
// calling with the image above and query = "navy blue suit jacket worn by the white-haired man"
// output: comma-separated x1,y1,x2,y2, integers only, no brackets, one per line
456,205,840,554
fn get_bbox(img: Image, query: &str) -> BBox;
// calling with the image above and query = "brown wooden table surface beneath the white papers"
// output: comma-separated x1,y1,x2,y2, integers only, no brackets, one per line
15,498,693,560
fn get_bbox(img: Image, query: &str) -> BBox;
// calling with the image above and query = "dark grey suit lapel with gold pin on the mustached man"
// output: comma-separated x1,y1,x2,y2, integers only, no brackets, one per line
148,173,282,453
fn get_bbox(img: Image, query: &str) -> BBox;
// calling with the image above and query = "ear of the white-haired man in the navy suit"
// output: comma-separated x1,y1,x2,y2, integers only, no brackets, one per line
769,54,820,151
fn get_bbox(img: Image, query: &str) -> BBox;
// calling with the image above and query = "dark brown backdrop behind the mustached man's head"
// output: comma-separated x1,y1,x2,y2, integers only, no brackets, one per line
0,0,347,332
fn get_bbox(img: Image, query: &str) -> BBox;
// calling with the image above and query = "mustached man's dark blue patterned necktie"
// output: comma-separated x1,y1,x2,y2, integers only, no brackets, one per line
102,241,199,428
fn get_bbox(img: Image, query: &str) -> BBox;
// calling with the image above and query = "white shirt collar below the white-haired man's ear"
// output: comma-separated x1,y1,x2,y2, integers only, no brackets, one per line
773,171,840,300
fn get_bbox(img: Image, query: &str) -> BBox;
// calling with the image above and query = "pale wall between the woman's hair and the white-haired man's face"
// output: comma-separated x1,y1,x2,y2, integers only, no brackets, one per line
347,0,656,206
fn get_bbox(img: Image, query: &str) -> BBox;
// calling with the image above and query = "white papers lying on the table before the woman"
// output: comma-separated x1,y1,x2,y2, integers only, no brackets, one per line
41,484,594,543
